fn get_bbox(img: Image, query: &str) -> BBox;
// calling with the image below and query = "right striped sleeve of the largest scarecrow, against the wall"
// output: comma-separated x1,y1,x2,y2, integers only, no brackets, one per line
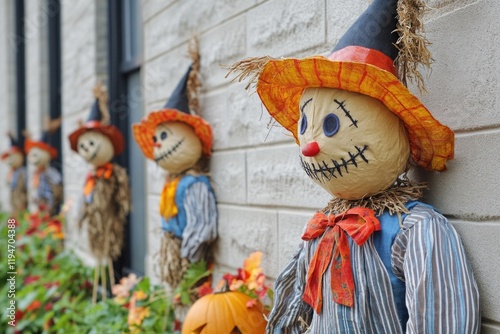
392,205,481,334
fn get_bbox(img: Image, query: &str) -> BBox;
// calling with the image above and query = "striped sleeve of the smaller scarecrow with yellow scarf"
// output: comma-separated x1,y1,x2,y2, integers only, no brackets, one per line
181,182,217,262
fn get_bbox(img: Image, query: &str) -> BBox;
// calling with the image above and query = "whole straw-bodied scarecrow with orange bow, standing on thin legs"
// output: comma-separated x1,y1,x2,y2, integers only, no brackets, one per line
69,83,130,302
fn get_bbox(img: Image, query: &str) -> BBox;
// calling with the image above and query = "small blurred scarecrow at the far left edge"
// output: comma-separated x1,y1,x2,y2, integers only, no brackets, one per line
1,133,28,217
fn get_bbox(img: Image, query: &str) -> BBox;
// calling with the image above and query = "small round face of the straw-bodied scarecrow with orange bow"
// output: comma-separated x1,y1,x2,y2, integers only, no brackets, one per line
77,131,115,167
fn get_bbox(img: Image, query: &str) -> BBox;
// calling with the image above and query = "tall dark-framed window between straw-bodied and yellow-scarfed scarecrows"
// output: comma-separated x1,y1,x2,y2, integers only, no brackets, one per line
108,0,146,275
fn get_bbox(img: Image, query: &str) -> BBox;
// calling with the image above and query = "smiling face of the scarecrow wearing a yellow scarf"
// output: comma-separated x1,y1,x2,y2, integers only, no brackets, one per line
153,122,202,173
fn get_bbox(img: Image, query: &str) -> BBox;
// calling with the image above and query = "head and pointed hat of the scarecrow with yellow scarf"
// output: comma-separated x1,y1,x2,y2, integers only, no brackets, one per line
132,67,212,174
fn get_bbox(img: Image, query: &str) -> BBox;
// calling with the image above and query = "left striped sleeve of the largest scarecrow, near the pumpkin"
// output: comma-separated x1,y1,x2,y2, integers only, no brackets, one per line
266,243,313,334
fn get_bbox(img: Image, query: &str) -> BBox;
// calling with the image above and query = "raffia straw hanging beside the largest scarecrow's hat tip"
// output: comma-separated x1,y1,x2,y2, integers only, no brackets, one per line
396,0,433,93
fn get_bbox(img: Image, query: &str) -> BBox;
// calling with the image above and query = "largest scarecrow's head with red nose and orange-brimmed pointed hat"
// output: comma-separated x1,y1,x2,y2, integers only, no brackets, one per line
231,0,454,200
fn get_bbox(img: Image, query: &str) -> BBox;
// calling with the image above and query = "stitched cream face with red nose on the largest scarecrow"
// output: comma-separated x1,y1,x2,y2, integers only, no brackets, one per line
298,88,410,200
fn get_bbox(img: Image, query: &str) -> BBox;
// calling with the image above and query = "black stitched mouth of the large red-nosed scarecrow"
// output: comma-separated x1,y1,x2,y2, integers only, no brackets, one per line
300,145,368,182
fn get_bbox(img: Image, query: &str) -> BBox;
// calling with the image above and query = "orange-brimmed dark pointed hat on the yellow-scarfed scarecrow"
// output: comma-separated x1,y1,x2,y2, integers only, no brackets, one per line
132,66,212,160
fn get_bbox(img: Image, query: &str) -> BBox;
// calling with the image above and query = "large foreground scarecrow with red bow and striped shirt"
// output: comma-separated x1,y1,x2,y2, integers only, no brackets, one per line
229,0,480,333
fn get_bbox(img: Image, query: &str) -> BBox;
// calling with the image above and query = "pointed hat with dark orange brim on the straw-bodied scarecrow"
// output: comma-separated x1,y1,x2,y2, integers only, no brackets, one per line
68,85,125,155
